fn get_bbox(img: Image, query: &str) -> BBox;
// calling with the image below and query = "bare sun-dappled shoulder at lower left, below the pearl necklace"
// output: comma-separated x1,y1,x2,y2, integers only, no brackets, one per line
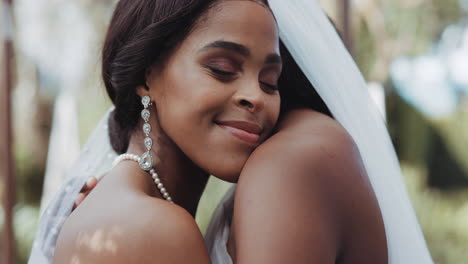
54,194,210,264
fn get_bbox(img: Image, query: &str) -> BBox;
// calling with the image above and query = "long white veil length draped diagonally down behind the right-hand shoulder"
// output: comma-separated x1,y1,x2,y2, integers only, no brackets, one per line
269,0,433,264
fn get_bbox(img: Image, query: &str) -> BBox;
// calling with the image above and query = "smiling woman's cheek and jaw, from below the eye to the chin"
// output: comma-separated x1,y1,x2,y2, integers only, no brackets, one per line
156,63,250,177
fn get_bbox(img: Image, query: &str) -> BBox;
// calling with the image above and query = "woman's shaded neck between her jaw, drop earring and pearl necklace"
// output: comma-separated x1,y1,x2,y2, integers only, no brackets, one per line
127,116,209,217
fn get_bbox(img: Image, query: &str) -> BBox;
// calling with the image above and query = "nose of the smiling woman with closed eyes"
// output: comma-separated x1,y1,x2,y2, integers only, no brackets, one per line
234,83,265,112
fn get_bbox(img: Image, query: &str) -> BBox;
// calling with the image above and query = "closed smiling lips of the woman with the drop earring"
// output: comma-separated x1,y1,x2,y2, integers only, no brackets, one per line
216,121,263,145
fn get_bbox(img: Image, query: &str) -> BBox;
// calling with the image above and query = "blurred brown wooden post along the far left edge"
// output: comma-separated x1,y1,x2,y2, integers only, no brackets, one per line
0,0,15,264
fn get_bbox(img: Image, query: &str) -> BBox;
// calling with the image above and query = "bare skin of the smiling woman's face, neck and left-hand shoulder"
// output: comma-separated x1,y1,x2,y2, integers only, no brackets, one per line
54,1,281,264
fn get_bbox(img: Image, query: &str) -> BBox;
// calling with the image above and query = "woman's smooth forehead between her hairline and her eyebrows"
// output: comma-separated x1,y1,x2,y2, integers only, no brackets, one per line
187,0,278,53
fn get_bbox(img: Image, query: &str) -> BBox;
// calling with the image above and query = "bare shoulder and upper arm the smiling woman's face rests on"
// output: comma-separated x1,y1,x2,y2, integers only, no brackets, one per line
234,110,386,263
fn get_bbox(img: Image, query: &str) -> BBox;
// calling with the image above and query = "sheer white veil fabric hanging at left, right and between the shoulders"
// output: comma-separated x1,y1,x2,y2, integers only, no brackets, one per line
28,0,433,264
